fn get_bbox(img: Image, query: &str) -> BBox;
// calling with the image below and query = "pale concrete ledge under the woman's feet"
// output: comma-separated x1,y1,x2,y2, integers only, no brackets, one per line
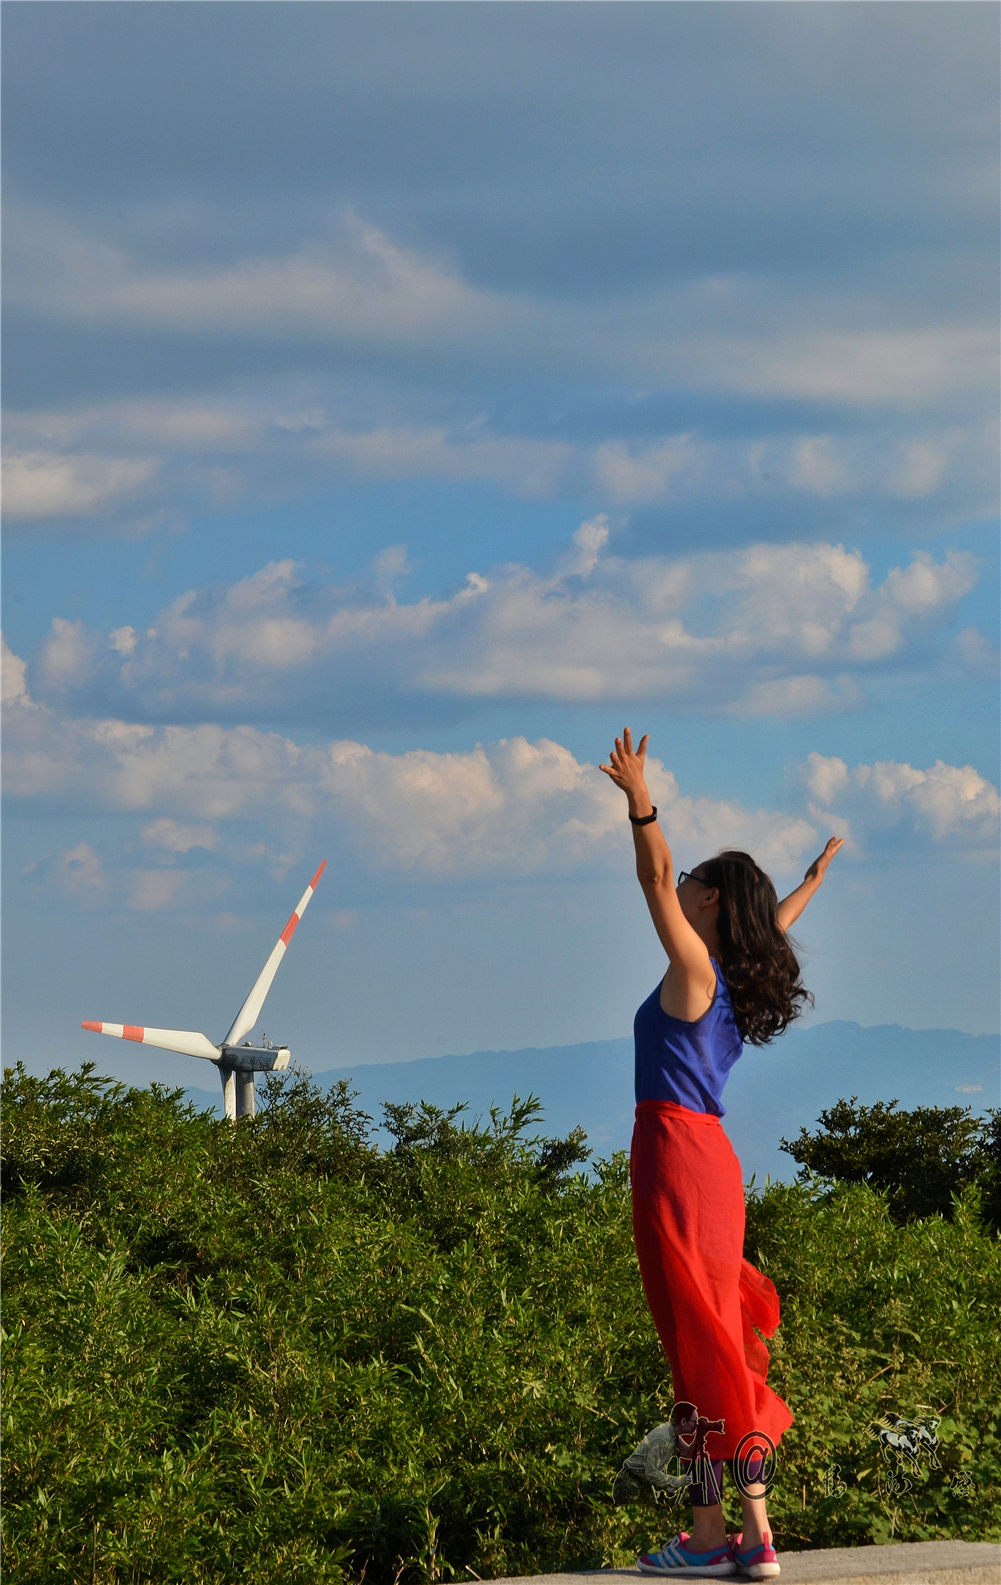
481,1541,1001,1585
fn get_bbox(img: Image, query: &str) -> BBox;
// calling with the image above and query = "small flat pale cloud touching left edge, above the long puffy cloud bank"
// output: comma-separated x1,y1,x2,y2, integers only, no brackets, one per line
3,450,157,521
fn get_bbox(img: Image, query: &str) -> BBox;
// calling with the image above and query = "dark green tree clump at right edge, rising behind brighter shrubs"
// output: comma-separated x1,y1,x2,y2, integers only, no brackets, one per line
781,1095,1001,1230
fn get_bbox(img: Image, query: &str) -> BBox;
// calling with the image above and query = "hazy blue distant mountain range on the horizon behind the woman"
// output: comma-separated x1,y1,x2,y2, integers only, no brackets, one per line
187,1022,1001,1182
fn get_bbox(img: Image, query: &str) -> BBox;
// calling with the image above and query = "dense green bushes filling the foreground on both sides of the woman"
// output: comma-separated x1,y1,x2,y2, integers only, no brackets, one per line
3,1068,1001,1585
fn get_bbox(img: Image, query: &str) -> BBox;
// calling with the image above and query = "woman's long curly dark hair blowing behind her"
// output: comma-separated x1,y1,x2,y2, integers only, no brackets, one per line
698,848,813,1046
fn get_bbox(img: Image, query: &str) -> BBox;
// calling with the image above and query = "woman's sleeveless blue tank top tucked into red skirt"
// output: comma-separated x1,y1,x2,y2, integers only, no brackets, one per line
632,957,743,1117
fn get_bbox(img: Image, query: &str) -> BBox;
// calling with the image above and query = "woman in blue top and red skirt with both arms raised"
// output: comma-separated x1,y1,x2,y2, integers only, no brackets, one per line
602,728,841,1579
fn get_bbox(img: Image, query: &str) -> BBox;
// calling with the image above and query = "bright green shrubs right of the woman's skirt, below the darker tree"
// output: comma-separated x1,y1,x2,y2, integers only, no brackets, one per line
744,1184,1001,1547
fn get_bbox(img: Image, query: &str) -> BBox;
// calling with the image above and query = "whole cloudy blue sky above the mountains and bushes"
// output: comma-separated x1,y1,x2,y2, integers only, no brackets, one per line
3,0,999,1084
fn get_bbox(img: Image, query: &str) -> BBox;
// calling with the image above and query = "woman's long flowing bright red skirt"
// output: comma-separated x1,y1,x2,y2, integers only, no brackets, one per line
630,1100,792,1458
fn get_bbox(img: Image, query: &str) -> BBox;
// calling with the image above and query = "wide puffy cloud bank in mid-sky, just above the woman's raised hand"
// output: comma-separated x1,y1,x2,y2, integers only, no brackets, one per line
33,529,976,720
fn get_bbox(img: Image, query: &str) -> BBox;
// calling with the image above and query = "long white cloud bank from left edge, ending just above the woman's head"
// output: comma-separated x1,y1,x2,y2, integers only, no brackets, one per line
5,659,816,881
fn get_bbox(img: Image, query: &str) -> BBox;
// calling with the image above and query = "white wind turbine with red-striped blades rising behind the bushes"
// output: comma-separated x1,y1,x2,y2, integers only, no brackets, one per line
81,859,326,1121
